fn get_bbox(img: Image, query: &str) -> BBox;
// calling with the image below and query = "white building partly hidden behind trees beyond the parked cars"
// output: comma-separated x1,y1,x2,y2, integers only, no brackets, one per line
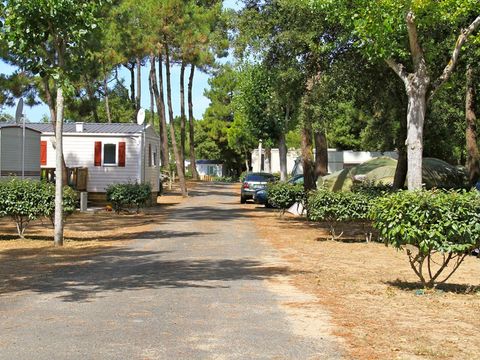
252,149,398,174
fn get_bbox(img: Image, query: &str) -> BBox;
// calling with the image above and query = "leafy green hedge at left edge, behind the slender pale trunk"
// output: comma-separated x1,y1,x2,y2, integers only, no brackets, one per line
0,179,77,238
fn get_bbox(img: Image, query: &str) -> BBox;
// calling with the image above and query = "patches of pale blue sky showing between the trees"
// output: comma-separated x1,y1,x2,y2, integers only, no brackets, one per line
0,0,239,122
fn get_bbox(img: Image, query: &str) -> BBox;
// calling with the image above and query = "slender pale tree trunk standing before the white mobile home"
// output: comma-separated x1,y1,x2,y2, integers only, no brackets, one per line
54,87,64,246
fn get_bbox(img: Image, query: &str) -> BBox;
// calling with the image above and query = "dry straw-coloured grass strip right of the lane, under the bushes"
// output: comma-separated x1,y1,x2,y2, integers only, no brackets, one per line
248,210,480,359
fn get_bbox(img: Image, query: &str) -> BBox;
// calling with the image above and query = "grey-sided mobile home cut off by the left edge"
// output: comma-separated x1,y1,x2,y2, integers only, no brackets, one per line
0,123,40,179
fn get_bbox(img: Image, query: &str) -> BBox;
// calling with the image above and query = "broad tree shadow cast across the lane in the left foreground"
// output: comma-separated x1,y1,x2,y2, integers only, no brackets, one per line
0,248,291,302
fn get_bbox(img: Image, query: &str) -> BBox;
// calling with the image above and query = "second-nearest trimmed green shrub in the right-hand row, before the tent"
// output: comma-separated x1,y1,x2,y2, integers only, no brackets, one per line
306,188,372,239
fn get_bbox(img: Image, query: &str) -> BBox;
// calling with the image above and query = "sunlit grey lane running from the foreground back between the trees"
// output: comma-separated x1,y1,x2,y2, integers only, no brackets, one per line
0,184,345,360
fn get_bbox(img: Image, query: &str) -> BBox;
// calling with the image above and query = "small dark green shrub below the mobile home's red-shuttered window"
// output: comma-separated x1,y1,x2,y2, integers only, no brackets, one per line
107,183,152,214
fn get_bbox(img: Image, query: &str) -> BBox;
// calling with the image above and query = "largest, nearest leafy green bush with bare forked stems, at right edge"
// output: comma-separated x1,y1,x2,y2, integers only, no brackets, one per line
370,190,480,288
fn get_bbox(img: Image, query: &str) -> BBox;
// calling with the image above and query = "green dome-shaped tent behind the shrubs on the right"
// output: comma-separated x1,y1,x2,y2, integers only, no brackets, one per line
318,157,467,191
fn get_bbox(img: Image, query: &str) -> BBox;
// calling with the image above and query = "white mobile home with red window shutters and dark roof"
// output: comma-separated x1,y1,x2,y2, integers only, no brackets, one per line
29,123,160,198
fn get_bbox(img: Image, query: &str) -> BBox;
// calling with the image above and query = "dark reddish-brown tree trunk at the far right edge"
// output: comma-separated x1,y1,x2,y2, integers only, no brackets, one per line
465,64,480,186
